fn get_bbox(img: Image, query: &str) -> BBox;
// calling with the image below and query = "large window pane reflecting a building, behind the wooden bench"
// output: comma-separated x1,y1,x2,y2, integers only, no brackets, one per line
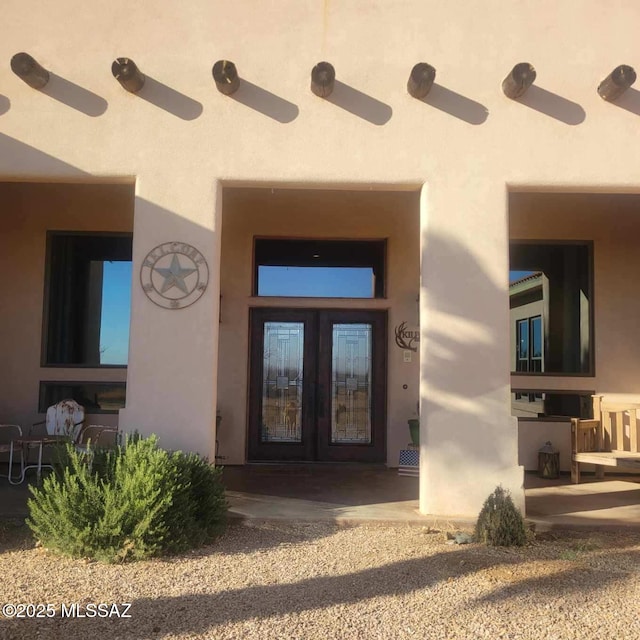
509,242,593,374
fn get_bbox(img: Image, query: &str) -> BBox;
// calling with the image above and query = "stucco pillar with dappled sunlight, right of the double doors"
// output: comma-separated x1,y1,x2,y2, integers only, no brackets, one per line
420,176,524,517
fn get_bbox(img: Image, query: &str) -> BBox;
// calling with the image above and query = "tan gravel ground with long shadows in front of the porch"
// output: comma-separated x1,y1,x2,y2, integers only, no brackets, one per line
0,522,640,640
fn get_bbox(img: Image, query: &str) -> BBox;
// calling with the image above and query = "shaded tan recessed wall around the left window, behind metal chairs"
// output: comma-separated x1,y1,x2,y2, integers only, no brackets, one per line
0,182,134,429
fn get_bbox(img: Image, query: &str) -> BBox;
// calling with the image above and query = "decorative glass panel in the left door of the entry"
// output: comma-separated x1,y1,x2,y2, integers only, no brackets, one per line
260,322,304,442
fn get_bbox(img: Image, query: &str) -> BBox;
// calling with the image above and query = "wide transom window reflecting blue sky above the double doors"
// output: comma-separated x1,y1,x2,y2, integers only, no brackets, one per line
254,238,386,298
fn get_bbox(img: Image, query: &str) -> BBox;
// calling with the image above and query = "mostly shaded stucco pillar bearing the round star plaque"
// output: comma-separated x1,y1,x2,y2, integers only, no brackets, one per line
120,171,222,460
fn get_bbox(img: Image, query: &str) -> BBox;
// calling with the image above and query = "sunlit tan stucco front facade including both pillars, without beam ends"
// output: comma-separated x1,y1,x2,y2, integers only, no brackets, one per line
0,0,640,515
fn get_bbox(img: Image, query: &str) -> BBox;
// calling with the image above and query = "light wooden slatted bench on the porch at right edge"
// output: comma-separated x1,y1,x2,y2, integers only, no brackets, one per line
571,394,640,483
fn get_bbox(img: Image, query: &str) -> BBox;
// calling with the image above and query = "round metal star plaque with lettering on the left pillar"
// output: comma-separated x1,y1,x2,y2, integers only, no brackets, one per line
140,242,209,309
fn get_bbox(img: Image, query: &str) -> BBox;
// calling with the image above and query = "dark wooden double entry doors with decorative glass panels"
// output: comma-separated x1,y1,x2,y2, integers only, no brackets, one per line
248,308,386,462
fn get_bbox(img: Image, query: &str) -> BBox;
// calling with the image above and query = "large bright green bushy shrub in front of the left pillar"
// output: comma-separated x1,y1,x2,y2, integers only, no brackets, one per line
27,436,226,562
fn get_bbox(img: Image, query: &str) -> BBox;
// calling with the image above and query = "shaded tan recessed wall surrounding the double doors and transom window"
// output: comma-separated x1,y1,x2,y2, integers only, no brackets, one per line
218,189,420,466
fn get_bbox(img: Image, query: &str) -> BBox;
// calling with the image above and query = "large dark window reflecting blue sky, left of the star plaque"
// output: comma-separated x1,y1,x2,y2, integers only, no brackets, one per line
43,233,132,367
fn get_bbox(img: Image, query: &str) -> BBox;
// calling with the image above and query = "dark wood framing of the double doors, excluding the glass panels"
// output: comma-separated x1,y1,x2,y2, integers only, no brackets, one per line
247,307,387,462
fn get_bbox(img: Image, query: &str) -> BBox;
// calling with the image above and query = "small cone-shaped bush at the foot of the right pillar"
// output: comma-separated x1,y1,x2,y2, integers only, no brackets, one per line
475,487,527,547
